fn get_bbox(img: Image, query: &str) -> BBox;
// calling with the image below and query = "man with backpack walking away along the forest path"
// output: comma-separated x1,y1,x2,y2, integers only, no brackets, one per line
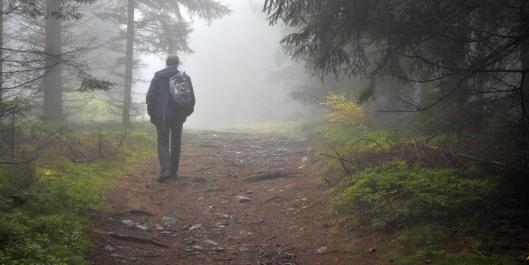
146,55,195,182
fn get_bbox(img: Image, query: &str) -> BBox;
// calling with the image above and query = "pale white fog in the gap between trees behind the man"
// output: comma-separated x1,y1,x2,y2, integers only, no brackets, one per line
135,0,310,128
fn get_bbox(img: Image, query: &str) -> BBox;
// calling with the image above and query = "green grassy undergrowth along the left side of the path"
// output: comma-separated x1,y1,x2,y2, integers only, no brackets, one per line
0,121,154,265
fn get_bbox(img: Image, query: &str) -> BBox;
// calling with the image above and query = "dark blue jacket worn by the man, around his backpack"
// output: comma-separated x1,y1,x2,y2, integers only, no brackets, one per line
146,67,195,126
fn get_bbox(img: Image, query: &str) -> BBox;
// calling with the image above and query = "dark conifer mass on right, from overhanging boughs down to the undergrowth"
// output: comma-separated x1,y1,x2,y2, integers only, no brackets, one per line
264,0,529,173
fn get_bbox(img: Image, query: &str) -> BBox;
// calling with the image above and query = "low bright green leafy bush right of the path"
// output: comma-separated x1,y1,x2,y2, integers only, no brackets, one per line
338,161,496,229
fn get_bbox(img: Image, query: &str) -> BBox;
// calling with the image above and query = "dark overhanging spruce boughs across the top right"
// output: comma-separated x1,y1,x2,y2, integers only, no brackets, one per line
264,0,529,99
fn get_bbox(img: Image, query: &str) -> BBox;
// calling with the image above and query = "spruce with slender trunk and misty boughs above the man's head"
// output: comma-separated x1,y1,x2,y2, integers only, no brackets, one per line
103,0,230,126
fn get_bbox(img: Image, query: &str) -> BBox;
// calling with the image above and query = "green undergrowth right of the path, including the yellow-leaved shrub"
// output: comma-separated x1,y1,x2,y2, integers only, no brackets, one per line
307,95,528,265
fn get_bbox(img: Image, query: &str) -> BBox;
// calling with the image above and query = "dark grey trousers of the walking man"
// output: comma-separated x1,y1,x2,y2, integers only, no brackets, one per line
156,122,183,174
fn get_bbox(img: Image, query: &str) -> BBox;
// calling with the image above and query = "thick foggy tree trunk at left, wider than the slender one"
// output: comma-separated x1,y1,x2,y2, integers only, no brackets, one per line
43,0,64,121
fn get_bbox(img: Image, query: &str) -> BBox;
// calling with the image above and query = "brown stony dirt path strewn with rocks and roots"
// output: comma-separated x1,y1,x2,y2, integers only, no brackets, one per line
88,131,351,265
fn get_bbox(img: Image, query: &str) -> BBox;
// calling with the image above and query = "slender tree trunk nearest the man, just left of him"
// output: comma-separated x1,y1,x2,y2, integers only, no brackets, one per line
121,0,135,127
